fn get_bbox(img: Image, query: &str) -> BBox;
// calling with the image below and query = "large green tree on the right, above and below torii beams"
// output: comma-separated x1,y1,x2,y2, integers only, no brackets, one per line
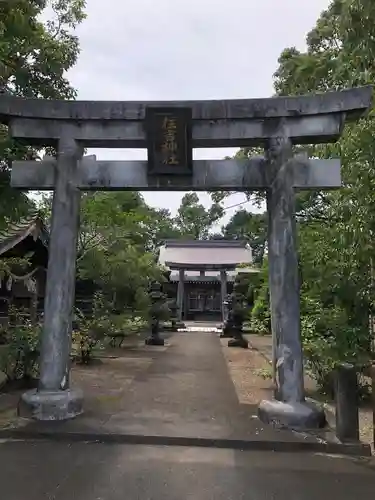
264,0,375,390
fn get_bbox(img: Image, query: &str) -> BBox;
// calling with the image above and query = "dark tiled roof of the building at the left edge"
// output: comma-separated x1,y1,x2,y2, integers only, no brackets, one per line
0,213,49,255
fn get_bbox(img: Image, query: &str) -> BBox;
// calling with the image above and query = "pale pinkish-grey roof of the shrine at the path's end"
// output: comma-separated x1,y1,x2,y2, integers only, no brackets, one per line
159,240,253,269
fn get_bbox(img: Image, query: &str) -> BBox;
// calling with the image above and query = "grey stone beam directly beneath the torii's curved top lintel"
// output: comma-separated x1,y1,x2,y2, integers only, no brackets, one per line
9,114,344,148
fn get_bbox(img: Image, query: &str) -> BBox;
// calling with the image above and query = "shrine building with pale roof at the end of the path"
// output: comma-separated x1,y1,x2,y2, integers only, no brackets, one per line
159,240,258,321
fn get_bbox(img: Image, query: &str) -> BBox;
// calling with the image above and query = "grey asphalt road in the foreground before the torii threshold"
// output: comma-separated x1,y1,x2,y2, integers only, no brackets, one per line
0,441,375,500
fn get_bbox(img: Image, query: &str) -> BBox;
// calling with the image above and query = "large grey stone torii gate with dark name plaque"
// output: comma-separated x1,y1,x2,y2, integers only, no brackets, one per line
0,87,372,427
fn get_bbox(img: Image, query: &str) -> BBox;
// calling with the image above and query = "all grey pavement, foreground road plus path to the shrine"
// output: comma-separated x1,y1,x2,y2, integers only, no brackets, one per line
0,332,375,500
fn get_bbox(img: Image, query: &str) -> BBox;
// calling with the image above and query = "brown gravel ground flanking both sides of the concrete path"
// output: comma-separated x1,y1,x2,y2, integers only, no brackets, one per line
0,335,373,452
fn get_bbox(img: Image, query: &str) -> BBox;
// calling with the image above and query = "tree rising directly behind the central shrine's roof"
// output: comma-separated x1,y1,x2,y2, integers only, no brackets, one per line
175,193,224,240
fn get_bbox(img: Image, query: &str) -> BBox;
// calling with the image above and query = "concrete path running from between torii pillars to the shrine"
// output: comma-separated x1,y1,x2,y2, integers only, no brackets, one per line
3,332,315,442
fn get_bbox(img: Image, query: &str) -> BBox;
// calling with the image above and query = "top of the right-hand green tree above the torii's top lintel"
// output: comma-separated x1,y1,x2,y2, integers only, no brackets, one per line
275,0,375,95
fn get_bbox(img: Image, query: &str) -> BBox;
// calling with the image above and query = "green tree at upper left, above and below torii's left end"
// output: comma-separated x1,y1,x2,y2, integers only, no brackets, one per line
0,0,85,225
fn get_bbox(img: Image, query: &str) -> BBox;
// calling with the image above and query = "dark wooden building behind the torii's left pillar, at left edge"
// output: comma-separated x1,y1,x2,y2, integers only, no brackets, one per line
0,214,49,322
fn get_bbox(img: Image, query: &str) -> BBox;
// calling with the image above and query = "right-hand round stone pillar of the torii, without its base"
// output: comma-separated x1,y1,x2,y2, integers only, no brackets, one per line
267,133,304,403
